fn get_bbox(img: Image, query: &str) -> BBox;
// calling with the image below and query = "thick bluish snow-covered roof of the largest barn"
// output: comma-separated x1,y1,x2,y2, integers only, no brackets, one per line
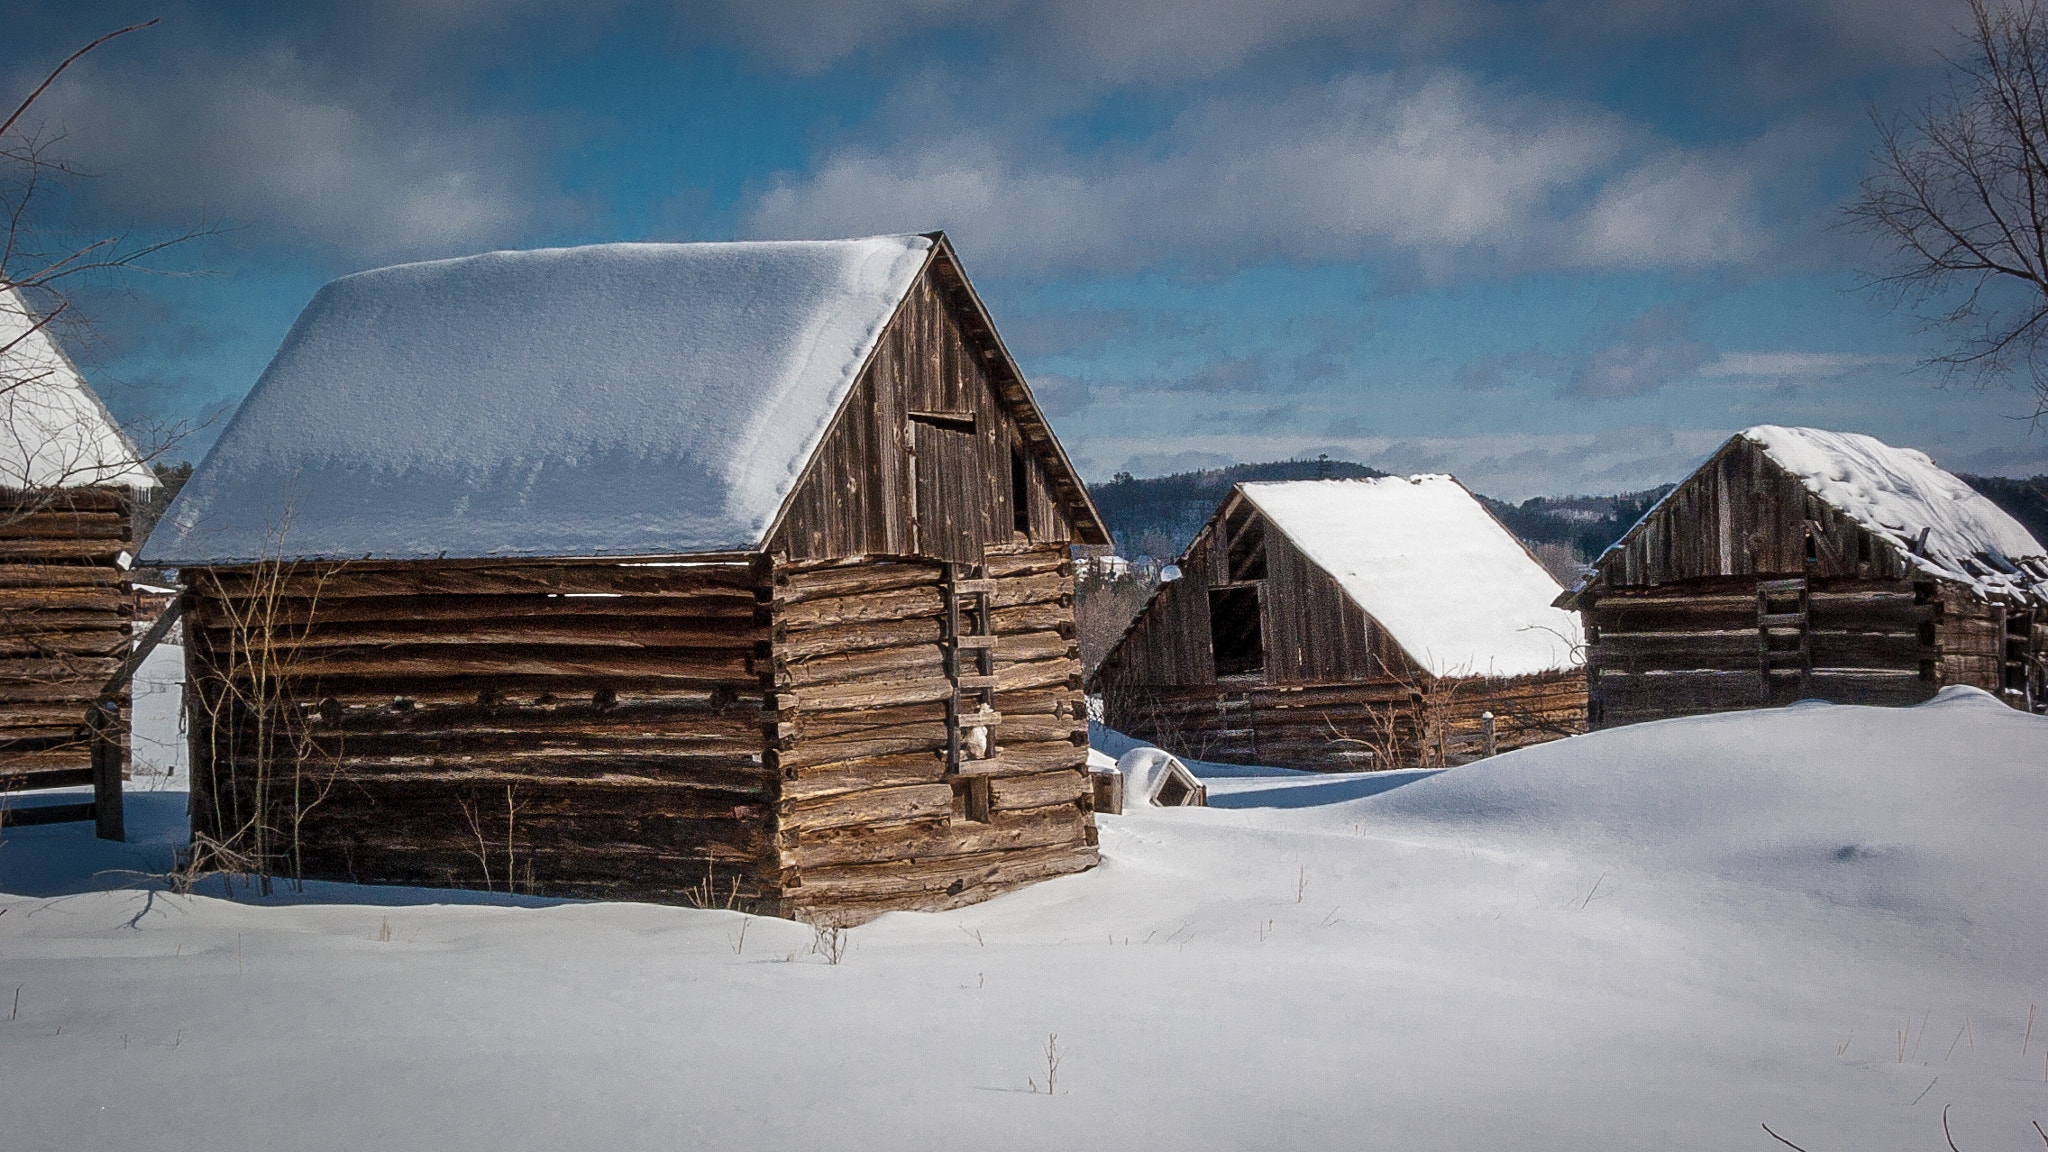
143,236,932,566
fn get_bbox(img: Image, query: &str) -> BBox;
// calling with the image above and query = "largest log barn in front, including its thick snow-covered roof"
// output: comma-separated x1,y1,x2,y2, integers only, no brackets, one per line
145,234,1108,920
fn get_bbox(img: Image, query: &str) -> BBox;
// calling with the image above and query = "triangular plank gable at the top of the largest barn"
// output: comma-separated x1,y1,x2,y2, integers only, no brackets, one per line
768,238,1108,564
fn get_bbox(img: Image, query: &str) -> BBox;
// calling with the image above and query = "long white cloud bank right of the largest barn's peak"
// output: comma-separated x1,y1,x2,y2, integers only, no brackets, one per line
743,74,1761,273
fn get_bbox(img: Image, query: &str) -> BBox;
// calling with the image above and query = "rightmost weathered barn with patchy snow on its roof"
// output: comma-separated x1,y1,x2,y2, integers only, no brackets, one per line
1559,424,2048,728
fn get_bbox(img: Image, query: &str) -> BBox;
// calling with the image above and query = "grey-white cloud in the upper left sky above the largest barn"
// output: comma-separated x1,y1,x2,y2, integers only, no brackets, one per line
19,47,561,258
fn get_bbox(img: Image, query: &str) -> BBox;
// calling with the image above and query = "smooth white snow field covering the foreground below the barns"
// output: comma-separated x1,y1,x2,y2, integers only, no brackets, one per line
0,676,2048,1152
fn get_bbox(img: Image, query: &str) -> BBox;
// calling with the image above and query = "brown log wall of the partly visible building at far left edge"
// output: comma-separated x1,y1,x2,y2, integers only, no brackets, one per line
0,488,135,793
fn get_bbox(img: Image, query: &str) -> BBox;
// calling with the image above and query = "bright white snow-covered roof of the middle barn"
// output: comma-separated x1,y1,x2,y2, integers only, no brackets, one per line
1239,476,1581,676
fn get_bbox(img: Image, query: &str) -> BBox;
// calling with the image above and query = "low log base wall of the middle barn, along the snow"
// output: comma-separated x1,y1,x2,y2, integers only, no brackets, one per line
1102,672,1585,771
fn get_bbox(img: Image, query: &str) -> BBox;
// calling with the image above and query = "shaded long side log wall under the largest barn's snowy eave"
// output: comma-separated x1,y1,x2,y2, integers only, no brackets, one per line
182,562,780,910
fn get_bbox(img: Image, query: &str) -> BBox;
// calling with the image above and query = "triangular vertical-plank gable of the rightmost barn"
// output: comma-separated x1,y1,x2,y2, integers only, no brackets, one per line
1593,437,1907,588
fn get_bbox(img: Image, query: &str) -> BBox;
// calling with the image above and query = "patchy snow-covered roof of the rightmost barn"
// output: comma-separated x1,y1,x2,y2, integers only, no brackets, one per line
1739,424,2048,592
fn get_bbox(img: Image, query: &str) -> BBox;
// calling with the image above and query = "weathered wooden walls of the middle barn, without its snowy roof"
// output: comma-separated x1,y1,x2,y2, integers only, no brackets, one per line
1094,494,1585,771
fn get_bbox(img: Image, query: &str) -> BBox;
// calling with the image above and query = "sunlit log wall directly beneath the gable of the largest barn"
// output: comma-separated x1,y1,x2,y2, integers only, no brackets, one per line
768,543,1096,918
